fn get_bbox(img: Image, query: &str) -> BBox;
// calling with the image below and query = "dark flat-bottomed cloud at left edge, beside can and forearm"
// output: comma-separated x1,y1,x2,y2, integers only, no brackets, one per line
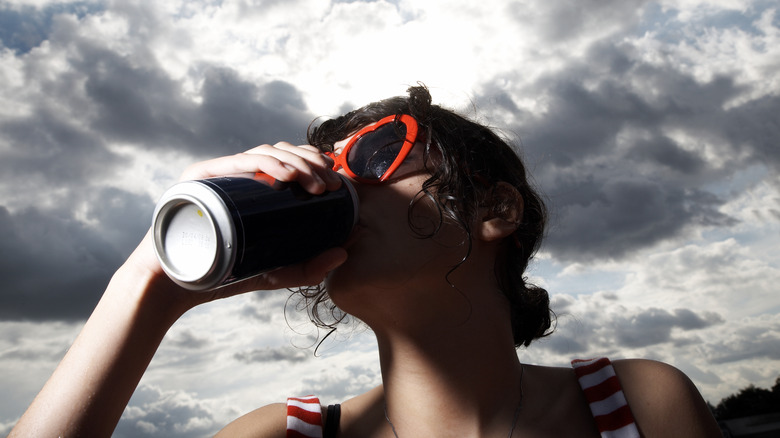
0,188,153,320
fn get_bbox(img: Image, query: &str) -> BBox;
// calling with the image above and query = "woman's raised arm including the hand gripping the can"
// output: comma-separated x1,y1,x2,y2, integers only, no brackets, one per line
10,143,346,437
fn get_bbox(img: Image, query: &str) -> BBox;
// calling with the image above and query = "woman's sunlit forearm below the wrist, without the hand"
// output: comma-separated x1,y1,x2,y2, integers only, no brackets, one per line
10,266,186,437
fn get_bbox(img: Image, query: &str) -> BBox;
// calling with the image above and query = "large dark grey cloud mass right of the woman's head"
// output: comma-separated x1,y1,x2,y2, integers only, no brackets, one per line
479,38,780,260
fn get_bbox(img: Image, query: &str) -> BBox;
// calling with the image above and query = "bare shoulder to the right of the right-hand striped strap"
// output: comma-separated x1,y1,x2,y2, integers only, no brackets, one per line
613,359,722,437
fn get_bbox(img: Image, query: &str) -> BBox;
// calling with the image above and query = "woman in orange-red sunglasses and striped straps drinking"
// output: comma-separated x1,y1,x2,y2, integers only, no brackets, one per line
11,87,720,437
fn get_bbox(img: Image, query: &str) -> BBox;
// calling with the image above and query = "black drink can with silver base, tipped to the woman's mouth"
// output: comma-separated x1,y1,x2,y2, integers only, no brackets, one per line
152,175,358,290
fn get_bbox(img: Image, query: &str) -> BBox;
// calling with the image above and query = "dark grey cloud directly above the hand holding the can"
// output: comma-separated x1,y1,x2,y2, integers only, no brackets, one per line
73,29,312,156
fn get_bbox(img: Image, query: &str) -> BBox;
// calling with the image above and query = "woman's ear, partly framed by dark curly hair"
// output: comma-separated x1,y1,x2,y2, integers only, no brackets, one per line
477,181,523,242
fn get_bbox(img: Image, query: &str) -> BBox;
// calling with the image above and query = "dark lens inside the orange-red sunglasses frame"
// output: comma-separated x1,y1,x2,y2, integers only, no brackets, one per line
347,123,406,180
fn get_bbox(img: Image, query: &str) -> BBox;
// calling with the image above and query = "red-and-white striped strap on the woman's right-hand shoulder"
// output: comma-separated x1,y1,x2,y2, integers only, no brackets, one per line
571,358,639,438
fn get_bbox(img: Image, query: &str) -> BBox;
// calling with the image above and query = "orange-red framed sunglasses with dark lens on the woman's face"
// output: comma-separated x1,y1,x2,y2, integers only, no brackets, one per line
327,114,417,184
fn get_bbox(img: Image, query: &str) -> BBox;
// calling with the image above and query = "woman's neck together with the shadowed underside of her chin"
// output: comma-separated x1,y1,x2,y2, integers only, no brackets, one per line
332,241,523,438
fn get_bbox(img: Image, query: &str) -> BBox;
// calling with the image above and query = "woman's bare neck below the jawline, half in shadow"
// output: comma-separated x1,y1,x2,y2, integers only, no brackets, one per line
377,302,522,437
